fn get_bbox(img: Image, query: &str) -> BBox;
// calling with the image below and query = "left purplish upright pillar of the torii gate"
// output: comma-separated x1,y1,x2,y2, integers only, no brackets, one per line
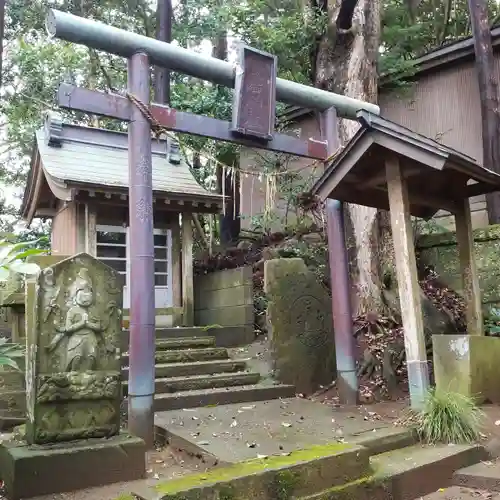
128,52,155,446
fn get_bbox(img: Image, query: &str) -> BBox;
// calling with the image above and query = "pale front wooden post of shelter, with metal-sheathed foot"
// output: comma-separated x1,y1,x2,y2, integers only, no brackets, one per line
386,156,429,410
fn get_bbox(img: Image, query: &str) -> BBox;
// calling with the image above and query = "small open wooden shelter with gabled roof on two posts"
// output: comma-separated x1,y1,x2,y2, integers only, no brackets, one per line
313,111,500,407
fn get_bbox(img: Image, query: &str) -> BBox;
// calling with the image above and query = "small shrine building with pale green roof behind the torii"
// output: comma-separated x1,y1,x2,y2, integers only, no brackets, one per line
21,112,223,326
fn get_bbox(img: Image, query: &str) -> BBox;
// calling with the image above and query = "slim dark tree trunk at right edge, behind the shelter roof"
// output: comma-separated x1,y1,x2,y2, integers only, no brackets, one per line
469,0,500,224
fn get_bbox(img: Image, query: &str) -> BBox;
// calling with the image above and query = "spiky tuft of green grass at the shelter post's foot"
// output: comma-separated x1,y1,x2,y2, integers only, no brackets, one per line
403,389,484,444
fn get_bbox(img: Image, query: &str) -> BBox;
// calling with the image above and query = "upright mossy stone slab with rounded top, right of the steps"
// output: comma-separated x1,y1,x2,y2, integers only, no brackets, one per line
264,259,336,394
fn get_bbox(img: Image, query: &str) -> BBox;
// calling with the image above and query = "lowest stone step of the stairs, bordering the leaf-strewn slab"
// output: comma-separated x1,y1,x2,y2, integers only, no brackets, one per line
150,384,295,411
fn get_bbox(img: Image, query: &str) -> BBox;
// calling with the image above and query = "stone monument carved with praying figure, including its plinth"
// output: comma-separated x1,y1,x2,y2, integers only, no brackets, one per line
0,254,145,499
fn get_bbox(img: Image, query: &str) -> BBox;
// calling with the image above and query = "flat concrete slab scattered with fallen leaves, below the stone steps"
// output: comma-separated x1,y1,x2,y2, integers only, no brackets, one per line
155,398,394,463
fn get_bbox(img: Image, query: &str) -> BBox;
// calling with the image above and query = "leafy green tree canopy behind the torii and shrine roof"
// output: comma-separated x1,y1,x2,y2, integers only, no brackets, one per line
0,0,500,245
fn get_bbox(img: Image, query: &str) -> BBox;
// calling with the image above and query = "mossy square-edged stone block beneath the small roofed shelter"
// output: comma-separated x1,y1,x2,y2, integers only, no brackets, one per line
432,335,500,404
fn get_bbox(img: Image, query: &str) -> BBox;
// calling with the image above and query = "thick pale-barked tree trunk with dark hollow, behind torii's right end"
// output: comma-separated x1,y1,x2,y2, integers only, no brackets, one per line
313,0,383,315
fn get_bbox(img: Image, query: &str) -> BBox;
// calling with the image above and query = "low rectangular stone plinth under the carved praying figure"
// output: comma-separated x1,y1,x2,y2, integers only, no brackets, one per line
0,433,146,500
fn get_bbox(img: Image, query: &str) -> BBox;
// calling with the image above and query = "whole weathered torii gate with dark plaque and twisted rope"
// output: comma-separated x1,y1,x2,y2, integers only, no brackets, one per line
46,10,379,446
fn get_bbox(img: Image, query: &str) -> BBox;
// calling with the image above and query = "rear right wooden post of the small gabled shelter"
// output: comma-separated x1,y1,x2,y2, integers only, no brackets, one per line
455,199,484,335
